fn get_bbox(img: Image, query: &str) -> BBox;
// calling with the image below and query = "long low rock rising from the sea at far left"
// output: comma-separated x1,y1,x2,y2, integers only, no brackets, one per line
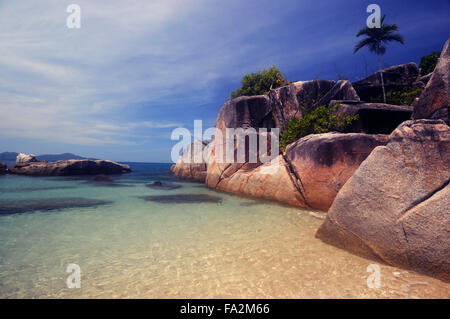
10,154,131,176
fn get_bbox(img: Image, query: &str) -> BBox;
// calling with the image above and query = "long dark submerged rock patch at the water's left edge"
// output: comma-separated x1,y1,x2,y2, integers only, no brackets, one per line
0,198,111,215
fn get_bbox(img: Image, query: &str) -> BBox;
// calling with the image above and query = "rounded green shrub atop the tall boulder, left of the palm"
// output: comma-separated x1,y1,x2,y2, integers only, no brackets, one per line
231,66,288,98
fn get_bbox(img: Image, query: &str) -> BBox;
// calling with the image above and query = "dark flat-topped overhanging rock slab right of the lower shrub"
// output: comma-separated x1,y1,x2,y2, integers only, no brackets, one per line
329,101,412,134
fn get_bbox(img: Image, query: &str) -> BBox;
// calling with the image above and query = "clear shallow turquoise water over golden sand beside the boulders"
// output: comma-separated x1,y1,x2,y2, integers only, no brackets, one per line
0,164,450,298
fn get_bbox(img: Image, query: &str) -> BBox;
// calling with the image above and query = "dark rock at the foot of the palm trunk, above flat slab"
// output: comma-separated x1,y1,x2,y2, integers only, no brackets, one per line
352,62,419,101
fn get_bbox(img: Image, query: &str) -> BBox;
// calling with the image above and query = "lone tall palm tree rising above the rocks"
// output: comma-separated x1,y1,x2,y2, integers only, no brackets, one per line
353,15,405,103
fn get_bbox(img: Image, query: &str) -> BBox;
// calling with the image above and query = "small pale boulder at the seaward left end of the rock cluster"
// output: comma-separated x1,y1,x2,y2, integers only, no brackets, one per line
171,140,208,182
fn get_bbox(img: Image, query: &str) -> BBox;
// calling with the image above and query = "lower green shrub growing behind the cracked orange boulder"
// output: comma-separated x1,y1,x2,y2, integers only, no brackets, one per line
280,104,358,152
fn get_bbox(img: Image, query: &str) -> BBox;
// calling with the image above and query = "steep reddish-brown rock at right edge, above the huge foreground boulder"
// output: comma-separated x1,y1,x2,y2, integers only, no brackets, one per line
413,39,450,124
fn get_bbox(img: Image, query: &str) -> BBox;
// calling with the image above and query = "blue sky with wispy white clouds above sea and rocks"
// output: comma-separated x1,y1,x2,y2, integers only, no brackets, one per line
0,0,450,162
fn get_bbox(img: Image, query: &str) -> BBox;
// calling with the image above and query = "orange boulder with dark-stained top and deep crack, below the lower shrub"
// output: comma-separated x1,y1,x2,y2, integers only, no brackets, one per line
210,133,387,211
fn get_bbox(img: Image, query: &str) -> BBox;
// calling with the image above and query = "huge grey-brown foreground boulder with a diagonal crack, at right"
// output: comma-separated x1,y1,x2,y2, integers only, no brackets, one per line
317,120,450,281
